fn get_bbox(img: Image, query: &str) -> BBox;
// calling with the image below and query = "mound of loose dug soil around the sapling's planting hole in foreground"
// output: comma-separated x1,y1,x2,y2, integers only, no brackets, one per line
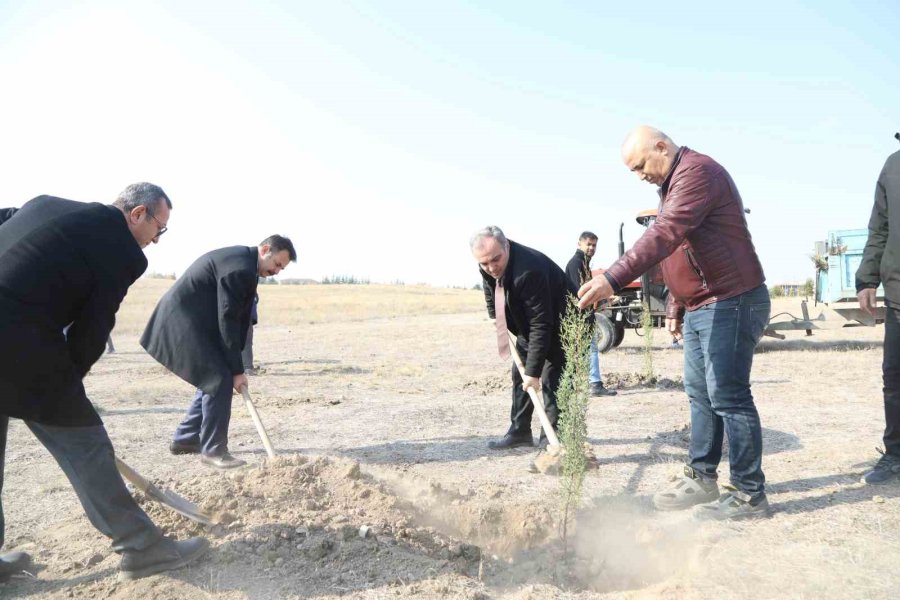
118,455,660,598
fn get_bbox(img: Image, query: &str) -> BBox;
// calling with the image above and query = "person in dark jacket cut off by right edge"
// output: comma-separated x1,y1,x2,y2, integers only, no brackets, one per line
856,143,900,484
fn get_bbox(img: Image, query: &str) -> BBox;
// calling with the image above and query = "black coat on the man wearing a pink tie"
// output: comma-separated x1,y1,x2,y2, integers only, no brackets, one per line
478,240,578,377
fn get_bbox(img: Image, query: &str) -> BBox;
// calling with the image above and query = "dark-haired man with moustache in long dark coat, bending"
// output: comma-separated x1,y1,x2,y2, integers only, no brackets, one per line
141,235,297,469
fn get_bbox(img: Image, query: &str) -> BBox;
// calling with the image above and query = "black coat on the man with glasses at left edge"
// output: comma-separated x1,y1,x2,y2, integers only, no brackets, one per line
0,196,147,427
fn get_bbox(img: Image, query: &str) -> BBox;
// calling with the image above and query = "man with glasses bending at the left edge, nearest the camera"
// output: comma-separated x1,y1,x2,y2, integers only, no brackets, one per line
0,183,208,581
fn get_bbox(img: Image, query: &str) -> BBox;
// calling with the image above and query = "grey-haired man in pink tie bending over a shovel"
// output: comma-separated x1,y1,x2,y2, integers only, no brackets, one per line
470,226,577,450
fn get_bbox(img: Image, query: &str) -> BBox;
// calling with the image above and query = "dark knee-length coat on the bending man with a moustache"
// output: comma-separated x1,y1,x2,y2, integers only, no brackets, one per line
141,246,258,393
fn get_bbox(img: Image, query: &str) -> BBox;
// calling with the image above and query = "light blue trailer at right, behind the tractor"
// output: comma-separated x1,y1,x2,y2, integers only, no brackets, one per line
815,229,884,326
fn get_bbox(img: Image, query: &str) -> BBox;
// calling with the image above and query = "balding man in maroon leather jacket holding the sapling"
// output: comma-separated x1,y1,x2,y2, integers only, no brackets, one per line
579,126,770,519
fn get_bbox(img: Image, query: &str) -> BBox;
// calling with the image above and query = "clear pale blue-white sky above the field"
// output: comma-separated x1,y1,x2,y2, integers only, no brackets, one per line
0,0,900,285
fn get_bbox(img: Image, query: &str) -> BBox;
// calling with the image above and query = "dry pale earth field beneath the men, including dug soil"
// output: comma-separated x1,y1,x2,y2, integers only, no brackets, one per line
0,280,900,600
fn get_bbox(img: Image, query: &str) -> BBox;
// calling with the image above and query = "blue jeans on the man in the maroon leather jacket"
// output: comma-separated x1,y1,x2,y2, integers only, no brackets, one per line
684,285,772,497
